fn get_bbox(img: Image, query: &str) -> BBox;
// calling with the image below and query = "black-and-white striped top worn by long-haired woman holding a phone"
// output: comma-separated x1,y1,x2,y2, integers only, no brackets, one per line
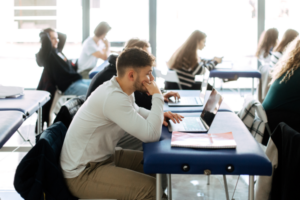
174,59,218,87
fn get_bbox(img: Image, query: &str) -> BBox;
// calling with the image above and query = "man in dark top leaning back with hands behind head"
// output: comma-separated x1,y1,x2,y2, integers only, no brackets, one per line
36,28,90,96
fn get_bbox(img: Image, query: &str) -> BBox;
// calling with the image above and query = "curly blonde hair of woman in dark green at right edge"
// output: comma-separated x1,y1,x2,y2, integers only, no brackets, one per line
270,36,300,85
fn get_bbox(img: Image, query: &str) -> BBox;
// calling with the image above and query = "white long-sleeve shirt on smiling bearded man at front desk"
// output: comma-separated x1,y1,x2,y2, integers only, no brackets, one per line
60,77,164,178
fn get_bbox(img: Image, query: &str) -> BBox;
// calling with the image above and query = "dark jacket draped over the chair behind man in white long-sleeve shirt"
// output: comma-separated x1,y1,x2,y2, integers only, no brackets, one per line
14,122,77,200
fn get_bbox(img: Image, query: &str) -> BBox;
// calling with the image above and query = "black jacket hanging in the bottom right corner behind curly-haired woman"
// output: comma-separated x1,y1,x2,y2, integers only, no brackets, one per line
269,123,300,200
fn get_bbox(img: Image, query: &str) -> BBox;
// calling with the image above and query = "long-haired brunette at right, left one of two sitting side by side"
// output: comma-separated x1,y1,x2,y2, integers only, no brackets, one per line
255,28,278,65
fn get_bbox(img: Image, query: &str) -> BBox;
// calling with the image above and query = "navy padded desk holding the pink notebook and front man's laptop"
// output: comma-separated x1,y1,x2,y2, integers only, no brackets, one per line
143,112,272,200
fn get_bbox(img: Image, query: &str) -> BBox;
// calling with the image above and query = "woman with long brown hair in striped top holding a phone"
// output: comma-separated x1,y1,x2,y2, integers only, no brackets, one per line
165,30,222,90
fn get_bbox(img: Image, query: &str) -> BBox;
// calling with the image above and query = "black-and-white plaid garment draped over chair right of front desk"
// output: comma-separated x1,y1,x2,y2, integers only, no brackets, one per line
238,96,271,143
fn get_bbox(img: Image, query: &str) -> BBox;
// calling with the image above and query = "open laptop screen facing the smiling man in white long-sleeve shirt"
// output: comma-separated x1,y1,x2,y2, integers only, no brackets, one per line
200,89,223,129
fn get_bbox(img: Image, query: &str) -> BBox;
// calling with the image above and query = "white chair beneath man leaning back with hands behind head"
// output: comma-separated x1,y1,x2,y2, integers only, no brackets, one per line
48,89,76,126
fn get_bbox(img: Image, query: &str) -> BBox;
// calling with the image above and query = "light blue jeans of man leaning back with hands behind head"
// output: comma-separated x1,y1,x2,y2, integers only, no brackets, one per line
64,79,91,96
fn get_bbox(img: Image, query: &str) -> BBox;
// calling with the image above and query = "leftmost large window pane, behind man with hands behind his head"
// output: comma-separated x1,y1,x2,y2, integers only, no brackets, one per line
0,0,82,88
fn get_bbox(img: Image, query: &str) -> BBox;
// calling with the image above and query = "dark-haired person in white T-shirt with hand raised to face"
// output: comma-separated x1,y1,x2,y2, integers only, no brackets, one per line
78,22,111,79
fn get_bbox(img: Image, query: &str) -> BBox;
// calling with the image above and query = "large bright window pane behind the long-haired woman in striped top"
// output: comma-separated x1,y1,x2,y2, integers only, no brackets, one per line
157,0,257,87
